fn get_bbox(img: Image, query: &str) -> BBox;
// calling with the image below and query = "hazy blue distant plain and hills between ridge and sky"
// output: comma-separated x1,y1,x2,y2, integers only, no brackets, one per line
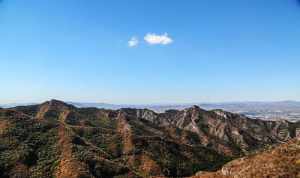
0,101,300,122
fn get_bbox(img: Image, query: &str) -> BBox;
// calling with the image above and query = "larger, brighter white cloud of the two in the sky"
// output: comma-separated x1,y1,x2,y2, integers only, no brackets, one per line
144,33,173,45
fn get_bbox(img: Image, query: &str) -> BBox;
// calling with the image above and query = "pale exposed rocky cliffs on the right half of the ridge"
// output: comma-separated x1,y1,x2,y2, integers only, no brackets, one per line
116,106,299,156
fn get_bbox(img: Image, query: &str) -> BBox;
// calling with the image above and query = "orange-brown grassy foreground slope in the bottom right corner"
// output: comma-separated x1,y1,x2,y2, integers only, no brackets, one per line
192,139,300,178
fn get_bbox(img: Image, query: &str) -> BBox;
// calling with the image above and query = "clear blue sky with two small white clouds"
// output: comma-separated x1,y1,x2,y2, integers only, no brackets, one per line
0,0,300,104
